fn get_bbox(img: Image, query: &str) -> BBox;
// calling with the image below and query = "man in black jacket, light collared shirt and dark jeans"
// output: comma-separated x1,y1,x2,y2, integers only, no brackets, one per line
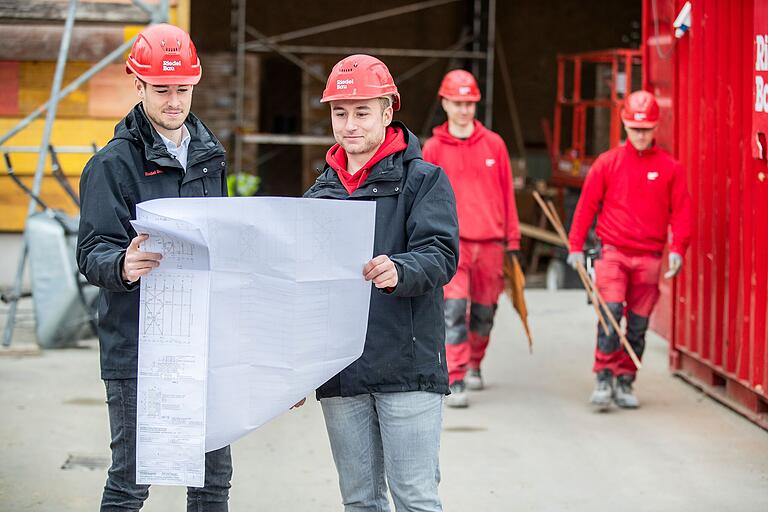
77,24,232,512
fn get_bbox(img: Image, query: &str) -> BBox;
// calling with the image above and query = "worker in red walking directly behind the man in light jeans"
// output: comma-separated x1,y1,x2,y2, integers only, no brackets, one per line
424,69,520,407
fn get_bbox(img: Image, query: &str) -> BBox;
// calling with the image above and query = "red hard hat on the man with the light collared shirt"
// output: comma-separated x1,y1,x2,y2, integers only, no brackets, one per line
125,23,203,85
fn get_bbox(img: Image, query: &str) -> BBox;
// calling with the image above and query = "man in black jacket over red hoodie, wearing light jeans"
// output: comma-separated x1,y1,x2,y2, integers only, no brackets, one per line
305,55,459,511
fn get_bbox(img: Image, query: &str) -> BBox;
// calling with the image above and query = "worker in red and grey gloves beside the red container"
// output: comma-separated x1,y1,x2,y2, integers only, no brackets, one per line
568,91,691,409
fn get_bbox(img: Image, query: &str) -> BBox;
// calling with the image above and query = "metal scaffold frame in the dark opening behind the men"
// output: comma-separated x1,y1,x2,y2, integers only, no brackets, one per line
232,0,496,171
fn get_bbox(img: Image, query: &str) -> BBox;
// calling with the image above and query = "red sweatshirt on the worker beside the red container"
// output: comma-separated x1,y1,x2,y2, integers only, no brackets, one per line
569,142,691,254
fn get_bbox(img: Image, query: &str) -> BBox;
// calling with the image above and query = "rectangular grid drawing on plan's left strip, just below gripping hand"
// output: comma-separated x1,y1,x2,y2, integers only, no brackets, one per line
141,273,192,338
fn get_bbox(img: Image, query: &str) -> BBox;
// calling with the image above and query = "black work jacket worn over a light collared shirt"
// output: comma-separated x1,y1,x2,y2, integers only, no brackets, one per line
77,103,227,379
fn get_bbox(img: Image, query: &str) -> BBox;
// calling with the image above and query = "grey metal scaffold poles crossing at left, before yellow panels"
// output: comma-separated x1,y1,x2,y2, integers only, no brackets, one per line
0,0,169,347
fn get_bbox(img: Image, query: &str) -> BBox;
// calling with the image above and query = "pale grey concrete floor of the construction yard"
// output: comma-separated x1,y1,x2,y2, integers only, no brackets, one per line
0,290,768,512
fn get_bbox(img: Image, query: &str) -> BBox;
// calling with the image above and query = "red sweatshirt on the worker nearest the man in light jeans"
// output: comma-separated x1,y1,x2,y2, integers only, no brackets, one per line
424,120,520,250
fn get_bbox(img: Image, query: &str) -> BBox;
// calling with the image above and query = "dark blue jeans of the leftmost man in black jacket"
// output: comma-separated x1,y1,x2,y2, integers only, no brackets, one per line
101,379,232,512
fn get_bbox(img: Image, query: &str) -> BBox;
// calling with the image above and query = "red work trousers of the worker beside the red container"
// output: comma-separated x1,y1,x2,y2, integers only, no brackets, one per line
593,245,661,376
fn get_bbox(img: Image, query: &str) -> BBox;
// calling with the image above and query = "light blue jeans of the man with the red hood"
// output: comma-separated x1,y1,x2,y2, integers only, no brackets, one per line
320,391,443,512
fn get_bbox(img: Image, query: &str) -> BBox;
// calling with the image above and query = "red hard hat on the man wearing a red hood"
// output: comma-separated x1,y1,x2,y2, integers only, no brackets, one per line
320,54,400,110
